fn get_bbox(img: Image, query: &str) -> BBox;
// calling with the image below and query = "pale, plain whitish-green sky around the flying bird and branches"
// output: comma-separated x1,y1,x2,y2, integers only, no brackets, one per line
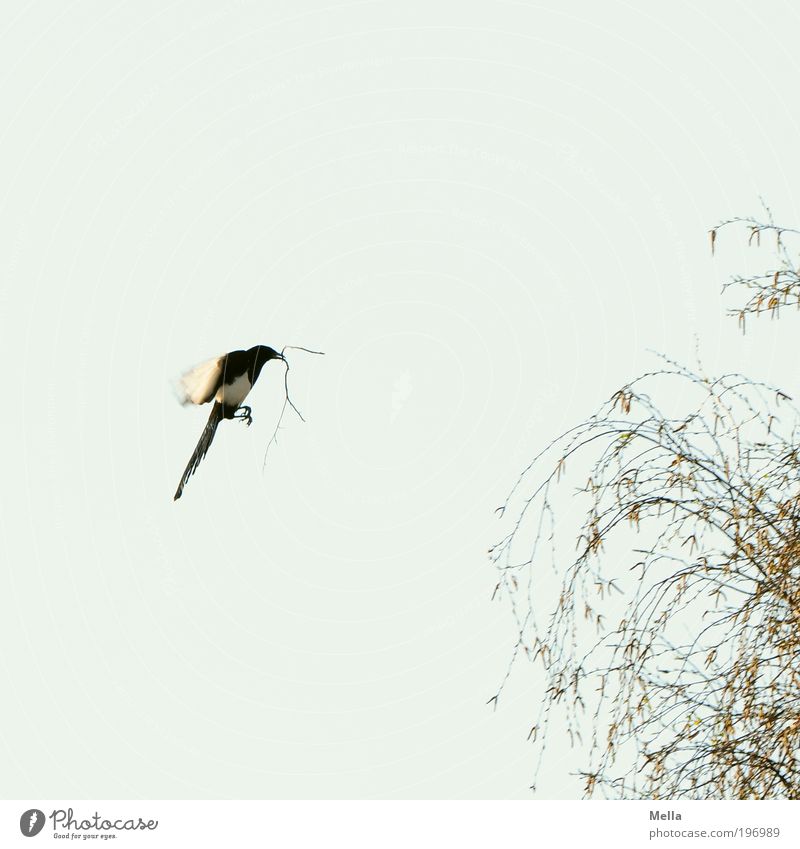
0,0,800,799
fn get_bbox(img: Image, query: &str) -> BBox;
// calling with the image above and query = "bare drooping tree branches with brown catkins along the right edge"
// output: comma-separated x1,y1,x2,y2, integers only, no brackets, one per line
490,210,800,799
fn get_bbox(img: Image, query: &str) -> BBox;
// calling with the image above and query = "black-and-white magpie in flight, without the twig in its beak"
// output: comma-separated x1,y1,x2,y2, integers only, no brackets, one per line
173,345,286,501
